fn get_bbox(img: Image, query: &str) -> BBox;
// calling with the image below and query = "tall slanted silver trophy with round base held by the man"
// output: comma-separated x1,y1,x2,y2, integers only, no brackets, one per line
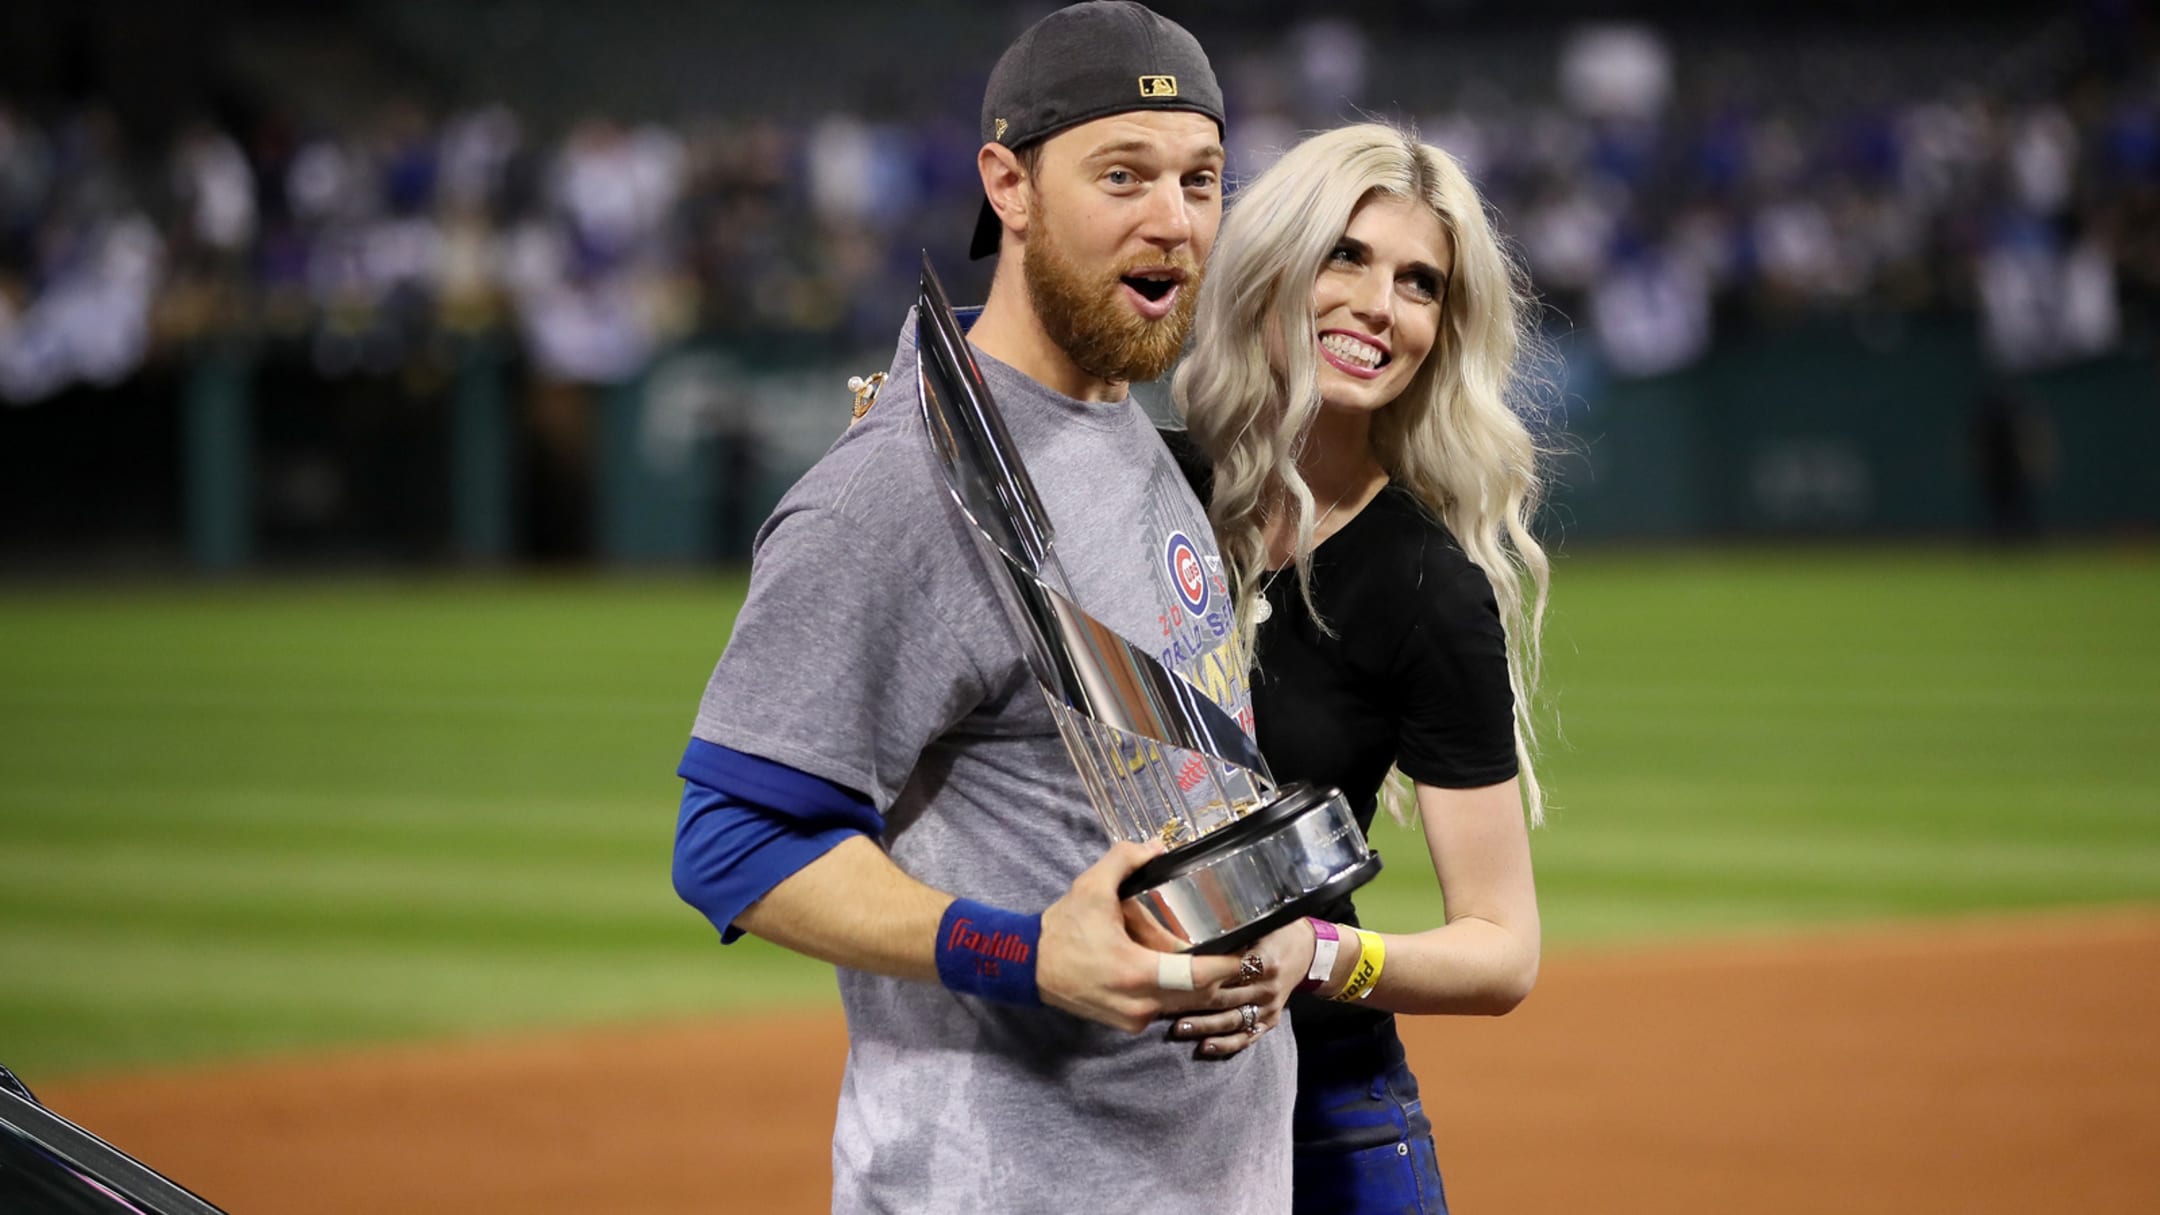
916,255,1380,953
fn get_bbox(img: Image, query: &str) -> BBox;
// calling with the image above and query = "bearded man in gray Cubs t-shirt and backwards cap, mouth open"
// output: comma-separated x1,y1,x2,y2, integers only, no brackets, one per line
676,2,1294,1213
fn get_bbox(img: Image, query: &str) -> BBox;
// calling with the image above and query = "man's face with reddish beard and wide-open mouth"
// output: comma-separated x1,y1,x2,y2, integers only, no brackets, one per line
1022,110,1223,383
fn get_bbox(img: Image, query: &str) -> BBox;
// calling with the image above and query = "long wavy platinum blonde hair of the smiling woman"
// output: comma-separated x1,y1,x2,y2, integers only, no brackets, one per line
1171,123,1551,824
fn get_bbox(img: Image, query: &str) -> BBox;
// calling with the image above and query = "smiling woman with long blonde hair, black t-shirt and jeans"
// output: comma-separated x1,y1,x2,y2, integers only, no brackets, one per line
1173,123,1547,1211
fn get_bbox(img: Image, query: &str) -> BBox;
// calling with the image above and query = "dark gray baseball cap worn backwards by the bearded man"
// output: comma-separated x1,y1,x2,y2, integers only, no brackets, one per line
968,0,1223,257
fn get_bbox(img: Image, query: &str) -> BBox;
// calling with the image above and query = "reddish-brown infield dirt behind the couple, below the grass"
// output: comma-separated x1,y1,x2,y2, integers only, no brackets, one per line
37,910,2160,1215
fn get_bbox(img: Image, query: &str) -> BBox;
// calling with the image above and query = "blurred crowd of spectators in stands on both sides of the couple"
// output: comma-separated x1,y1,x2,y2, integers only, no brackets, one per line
0,22,2160,402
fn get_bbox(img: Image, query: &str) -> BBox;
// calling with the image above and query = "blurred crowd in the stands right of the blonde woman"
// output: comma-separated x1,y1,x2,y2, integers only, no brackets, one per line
1494,30,2160,376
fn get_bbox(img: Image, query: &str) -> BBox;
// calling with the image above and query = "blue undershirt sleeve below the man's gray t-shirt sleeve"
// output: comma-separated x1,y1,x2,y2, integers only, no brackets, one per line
674,739,886,943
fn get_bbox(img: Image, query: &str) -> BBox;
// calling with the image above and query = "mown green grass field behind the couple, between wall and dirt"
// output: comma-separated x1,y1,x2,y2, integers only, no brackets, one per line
0,551,2160,1081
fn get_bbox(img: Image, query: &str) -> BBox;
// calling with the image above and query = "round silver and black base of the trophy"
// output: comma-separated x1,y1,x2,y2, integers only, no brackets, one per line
1117,785,1380,953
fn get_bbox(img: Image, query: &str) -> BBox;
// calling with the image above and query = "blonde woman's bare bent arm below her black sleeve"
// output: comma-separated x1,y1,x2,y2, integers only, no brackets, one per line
1320,780,1538,1016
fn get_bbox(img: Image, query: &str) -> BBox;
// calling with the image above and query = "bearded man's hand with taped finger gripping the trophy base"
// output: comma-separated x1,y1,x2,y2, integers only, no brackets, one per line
1035,843,1252,1033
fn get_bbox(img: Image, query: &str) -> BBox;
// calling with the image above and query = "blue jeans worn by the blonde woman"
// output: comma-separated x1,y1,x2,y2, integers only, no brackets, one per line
1292,1018,1447,1215
